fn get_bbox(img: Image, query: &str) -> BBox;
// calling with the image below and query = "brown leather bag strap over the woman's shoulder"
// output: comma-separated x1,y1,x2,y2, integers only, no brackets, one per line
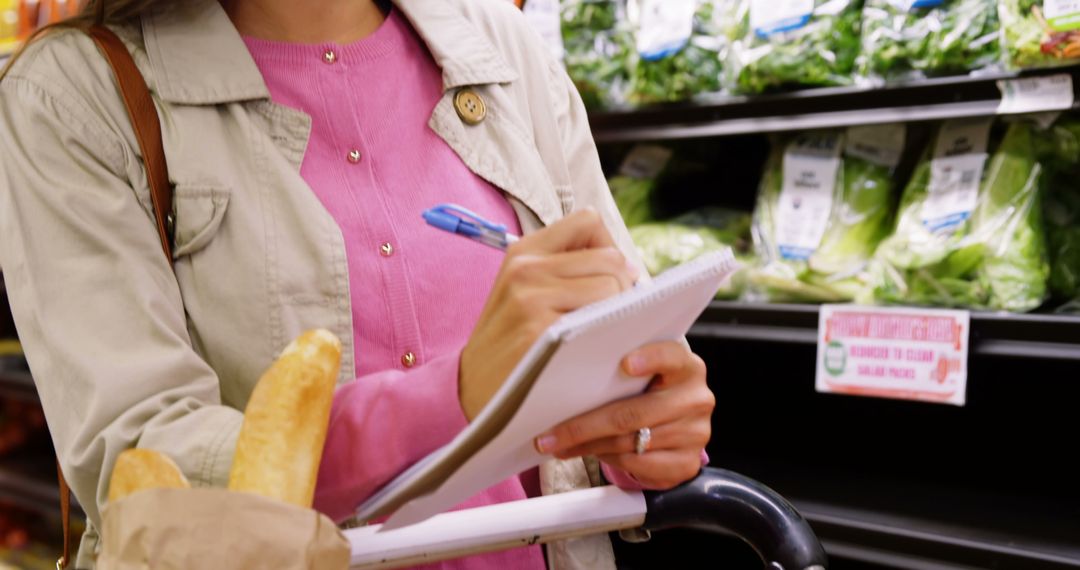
56,25,174,570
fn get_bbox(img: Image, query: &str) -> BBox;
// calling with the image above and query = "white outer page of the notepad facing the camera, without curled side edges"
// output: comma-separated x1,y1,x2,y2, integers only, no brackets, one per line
375,250,735,530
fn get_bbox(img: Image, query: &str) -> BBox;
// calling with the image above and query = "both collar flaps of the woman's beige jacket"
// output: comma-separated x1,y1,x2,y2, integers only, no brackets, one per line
143,0,517,105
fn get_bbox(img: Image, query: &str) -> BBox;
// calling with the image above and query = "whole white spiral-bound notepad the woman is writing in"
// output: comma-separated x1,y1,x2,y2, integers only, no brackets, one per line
356,249,738,530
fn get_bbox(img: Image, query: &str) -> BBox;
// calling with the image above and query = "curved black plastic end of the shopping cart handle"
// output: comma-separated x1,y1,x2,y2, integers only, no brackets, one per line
643,467,827,570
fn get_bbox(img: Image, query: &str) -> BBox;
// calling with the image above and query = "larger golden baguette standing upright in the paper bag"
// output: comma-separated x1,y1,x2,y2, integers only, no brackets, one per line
229,330,341,508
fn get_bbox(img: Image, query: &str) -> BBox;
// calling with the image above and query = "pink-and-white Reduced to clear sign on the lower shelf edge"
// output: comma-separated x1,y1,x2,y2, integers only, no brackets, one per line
816,304,971,406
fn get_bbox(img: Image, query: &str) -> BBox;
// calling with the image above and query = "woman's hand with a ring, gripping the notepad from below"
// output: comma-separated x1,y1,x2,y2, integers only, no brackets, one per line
536,342,716,490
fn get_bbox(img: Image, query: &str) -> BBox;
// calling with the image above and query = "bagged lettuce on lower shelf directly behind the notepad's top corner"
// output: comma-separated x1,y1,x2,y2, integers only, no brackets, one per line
630,207,753,299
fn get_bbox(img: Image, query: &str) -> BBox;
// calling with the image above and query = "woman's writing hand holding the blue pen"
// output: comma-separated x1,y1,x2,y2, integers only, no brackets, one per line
458,209,638,421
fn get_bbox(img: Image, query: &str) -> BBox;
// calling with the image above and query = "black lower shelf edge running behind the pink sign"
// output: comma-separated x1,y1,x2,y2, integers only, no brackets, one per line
689,301,1080,361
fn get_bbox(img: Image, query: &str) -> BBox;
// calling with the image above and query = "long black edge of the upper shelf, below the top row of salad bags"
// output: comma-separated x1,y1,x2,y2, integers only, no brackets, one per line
590,66,1080,143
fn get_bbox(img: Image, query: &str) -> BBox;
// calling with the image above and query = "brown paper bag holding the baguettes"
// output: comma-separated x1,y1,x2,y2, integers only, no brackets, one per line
97,489,350,570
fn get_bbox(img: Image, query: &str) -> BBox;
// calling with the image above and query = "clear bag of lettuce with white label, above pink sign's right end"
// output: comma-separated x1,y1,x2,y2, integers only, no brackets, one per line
872,119,1049,311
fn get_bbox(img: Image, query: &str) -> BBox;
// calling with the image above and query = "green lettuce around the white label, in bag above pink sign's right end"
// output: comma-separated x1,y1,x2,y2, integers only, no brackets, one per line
873,122,1049,311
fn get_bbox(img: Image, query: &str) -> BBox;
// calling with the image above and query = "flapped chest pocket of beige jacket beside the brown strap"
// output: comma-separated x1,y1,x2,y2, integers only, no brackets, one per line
173,185,229,259
